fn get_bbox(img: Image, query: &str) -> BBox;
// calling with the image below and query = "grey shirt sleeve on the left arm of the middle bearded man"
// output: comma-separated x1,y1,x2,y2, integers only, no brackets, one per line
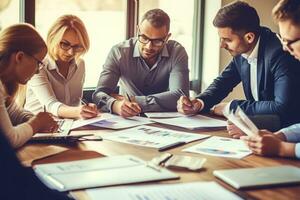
92,47,121,112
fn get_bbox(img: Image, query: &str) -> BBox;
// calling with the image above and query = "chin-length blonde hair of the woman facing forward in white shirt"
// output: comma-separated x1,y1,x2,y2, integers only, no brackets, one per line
47,15,90,60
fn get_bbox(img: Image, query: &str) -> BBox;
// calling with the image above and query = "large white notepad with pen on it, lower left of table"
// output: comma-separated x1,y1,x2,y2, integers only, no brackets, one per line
34,155,179,191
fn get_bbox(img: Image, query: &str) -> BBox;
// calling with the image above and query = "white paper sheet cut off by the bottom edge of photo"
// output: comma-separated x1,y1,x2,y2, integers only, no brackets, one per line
86,182,242,200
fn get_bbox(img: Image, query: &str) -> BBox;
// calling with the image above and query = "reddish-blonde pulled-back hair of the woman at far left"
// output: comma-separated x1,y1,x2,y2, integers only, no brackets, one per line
0,23,47,104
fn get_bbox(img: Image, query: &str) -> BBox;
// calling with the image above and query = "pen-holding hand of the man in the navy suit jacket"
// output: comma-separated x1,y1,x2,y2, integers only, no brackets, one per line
177,96,203,115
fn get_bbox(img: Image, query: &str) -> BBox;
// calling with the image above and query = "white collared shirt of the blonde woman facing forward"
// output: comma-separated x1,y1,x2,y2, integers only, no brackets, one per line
25,57,85,116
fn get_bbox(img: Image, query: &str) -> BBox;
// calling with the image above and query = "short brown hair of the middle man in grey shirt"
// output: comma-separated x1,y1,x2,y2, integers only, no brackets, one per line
141,8,170,32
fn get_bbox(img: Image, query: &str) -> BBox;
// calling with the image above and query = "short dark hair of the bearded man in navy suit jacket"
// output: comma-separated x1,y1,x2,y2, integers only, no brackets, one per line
213,1,260,35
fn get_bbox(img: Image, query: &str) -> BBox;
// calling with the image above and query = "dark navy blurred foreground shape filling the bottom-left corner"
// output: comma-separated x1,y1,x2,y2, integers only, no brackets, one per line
0,130,71,200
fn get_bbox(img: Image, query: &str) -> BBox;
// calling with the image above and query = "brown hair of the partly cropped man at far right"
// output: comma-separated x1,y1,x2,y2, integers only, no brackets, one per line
272,0,300,25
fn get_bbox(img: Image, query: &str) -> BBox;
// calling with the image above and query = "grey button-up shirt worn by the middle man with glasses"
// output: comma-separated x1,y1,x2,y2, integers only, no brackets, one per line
93,38,189,112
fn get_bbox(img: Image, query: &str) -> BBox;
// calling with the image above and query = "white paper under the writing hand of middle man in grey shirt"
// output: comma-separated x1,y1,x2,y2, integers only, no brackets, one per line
91,114,154,129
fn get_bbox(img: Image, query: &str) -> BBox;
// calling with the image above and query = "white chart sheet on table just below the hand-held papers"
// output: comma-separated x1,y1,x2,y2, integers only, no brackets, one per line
182,136,252,159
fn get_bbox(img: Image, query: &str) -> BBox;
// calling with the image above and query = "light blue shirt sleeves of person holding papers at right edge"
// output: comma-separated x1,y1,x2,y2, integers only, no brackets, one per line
280,123,300,159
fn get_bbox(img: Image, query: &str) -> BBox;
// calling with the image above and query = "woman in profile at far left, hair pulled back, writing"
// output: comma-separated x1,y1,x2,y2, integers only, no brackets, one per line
0,24,57,148
